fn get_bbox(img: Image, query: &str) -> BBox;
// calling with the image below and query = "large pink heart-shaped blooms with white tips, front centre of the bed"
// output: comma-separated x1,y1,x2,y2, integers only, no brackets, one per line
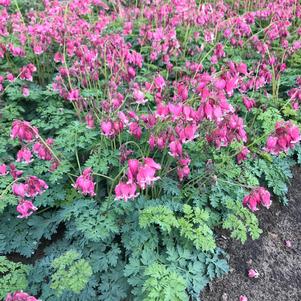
115,158,161,201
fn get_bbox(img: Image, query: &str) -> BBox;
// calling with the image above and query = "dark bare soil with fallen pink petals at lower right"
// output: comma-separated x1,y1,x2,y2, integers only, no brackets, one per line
201,168,301,301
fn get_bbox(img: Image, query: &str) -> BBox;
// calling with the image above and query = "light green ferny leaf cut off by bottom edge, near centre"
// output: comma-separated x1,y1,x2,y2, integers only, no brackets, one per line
143,262,189,301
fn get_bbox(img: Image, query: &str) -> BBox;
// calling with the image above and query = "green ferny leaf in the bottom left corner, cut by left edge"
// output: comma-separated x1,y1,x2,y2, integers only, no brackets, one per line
0,256,30,299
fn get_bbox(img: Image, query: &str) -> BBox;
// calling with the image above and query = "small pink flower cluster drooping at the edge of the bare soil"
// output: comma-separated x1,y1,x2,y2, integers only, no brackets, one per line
243,187,272,211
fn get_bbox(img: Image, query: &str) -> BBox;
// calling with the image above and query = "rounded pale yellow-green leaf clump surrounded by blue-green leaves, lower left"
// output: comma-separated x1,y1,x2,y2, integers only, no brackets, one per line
51,250,92,296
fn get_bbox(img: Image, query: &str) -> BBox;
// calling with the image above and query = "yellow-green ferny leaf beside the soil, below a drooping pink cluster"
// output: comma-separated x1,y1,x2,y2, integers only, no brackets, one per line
223,201,262,243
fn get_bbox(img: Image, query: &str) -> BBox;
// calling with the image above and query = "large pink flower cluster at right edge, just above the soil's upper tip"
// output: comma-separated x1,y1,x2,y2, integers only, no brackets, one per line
265,121,301,155
